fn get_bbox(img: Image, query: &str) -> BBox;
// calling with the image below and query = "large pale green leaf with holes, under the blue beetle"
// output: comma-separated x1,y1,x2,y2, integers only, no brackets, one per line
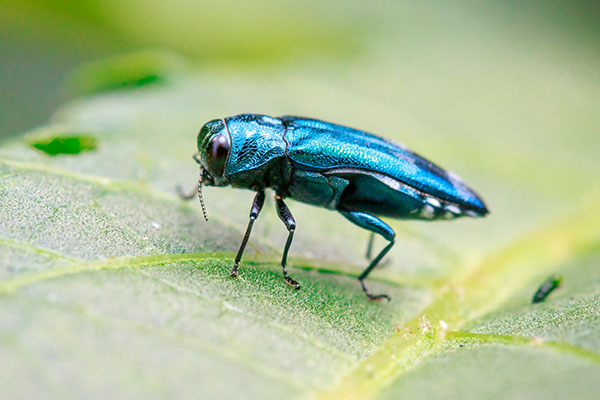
0,3,600,399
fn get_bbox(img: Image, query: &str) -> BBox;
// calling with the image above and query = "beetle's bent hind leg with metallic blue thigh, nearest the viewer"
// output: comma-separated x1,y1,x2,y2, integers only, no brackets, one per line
340,211,396,301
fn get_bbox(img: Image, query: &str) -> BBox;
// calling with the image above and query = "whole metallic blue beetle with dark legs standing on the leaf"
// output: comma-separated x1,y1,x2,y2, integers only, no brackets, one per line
180,114,489,300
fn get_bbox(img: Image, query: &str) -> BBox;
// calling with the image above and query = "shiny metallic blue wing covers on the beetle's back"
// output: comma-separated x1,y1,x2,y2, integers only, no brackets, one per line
281,116,488,216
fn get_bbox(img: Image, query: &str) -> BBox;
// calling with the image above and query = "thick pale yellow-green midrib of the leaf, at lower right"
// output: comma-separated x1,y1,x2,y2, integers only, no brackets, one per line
319,196,600,400
